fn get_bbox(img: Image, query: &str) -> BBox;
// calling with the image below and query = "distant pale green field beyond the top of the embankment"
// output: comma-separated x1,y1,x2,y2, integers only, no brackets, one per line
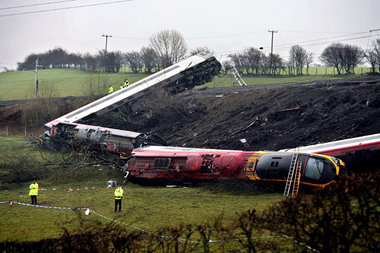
0,67,370,101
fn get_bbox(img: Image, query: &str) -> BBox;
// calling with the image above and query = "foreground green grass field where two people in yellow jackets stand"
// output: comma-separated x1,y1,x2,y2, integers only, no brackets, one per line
0,137,283,241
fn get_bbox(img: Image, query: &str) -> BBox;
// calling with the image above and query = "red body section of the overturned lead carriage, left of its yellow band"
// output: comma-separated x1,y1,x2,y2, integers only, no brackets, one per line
124,146,255,183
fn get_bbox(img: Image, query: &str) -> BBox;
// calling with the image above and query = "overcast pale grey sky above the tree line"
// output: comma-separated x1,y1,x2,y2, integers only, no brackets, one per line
0,0,380,70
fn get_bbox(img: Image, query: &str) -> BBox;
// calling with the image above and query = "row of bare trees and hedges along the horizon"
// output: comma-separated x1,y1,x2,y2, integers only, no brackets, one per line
17,30,380,75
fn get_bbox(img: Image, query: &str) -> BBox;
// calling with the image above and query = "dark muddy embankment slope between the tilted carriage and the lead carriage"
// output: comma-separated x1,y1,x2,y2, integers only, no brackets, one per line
86,77,380,153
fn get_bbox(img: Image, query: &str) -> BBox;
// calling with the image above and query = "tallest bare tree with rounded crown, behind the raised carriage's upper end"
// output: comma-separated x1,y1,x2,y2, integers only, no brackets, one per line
149,30,187,67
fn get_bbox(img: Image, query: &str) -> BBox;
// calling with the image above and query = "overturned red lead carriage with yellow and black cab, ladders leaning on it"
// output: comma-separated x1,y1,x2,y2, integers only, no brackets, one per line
124,146,346,187
